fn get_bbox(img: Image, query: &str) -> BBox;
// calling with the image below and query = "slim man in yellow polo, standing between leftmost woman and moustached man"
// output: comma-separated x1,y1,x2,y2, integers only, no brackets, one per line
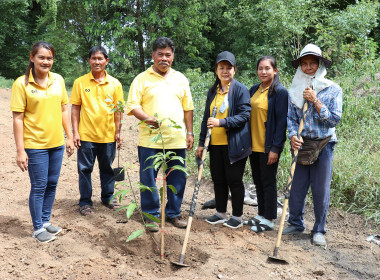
70,46,123,216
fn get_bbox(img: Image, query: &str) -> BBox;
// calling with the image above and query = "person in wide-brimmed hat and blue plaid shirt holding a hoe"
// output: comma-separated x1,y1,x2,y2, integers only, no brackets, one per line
283,44,342,246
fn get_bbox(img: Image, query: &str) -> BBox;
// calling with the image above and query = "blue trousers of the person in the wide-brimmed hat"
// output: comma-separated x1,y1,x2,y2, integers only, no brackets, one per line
288,142,335,234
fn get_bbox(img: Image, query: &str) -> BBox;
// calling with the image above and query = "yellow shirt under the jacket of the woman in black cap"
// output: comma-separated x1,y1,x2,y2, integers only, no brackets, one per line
210,84,230,145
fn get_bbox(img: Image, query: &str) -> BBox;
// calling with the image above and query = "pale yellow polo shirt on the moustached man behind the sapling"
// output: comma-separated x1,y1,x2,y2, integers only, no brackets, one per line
126,67,194,149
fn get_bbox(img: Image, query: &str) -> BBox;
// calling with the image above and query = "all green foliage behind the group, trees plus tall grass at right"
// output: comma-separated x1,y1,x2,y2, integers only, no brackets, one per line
0,0,380,223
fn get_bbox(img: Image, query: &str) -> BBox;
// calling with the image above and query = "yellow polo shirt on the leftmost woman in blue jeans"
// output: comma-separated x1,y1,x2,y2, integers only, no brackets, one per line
11,71,68,149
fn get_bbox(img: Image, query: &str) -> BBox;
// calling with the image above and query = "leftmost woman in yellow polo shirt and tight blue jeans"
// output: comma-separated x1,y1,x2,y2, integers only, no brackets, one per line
11,42,74,243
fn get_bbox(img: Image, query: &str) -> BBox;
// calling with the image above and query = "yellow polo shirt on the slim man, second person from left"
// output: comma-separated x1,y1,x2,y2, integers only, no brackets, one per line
70,72,124,143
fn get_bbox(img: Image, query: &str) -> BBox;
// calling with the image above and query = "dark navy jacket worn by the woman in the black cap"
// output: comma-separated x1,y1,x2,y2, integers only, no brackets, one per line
199,80,252,163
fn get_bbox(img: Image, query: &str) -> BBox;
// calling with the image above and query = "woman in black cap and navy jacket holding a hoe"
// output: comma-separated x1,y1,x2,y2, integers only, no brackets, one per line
196,51,251,229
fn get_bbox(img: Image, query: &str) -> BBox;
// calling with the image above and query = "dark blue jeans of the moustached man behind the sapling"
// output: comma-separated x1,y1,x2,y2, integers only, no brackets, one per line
138,146,186,218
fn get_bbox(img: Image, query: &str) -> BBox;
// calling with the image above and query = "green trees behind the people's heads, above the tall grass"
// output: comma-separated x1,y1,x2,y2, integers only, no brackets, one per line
0,0,380,86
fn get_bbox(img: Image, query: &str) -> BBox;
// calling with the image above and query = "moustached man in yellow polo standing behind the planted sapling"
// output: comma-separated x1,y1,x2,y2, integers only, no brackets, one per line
127,37,194,231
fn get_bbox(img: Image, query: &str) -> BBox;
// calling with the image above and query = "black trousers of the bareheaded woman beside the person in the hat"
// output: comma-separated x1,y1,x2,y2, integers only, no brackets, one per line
249,152,280,220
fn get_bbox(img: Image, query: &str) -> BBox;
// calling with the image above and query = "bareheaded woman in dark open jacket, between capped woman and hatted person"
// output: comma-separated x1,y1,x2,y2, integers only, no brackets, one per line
248,56,288,232
